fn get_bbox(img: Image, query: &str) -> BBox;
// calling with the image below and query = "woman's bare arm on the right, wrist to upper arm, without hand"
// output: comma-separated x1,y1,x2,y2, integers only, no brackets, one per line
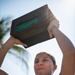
49,27,75,75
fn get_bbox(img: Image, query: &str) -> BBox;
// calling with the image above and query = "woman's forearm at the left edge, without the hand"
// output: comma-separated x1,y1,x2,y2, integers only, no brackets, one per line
0,37,14,67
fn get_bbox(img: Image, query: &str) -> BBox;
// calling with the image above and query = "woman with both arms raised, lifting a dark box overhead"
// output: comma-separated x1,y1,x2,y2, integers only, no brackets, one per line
0,20,75,75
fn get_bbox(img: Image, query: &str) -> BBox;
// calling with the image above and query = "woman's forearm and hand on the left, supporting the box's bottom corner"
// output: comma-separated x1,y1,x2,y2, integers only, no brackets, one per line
0,36,27,67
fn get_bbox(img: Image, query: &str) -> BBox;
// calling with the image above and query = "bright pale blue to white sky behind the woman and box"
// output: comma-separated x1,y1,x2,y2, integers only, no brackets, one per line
0,0,75,75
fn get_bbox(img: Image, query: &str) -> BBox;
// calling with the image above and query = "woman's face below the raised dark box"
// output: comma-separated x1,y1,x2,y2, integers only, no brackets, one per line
34,53,55,75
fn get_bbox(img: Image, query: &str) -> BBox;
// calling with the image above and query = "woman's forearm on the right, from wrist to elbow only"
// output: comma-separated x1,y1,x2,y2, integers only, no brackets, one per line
53,28,75,54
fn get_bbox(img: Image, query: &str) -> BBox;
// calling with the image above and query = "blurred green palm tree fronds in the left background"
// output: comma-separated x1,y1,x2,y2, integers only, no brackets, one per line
0,17,28,74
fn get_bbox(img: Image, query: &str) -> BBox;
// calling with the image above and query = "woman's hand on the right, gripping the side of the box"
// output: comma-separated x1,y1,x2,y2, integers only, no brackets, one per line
47,20,59,38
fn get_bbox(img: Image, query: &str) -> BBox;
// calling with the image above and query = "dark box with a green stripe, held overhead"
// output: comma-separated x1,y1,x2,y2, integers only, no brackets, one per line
10,5,56,47
